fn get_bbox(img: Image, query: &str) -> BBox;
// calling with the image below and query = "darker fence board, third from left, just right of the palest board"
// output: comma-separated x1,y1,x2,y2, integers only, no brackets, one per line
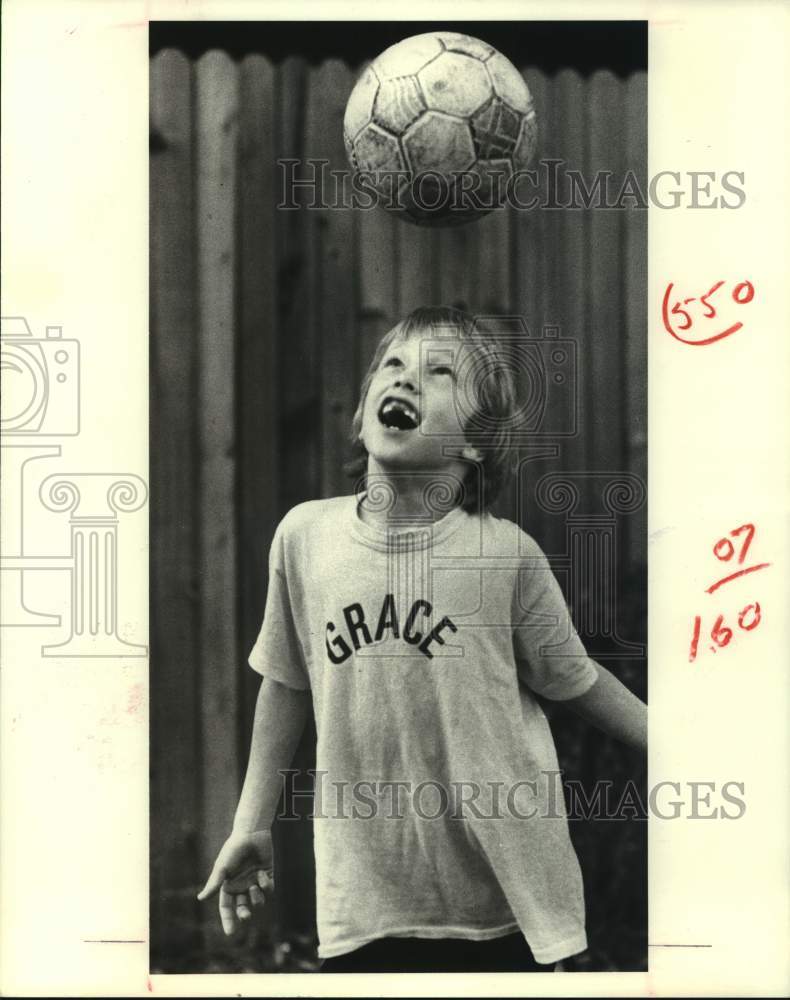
236,55,280,744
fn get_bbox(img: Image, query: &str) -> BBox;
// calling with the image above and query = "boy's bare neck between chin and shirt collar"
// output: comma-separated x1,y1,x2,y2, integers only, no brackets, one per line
357,463,461,528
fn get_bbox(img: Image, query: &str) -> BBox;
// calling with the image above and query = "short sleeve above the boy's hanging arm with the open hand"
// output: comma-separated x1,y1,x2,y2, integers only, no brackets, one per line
249,523,310,691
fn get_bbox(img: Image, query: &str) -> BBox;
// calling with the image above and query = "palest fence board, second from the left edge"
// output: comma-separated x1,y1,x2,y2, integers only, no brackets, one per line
195,52,239,896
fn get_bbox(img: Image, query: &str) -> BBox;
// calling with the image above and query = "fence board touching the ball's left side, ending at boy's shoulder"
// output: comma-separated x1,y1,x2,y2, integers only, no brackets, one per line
310,59,357,496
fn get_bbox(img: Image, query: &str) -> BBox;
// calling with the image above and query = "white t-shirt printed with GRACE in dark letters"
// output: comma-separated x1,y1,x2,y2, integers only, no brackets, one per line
250,496,597,963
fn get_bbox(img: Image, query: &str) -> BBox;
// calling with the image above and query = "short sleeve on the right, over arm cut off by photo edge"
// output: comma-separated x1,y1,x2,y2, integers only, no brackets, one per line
513,536,598,701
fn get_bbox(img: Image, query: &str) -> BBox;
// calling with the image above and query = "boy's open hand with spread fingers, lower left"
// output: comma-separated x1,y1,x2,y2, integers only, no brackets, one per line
198,830,274,935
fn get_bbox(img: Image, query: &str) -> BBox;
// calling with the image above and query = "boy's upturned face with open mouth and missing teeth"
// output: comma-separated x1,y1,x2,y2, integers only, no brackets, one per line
361,332,480,478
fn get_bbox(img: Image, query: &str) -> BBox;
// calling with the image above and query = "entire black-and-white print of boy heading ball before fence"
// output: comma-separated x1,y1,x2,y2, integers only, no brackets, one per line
150,21,648,974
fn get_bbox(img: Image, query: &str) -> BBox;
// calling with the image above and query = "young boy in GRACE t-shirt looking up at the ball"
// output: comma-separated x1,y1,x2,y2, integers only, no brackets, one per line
199,309,646,972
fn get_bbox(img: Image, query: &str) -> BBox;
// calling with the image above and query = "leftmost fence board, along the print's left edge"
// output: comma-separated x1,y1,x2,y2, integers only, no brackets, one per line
150,51,199,964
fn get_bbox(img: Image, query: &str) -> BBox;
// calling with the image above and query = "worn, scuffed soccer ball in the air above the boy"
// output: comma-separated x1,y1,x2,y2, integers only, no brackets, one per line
343,31,537,226
